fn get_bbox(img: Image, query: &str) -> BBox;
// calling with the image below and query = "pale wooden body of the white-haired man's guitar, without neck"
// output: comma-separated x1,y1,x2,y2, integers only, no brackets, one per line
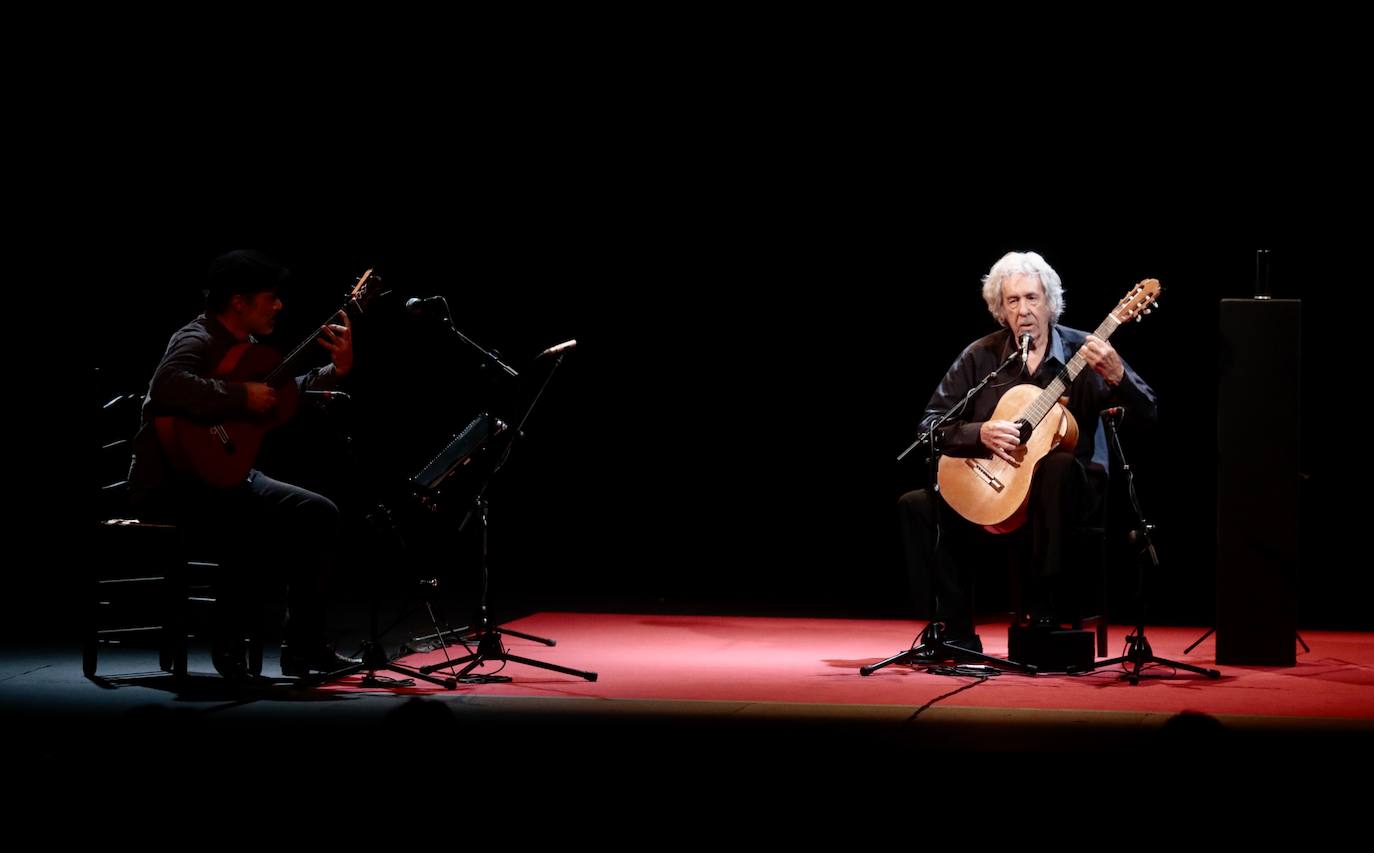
940,385,1079,533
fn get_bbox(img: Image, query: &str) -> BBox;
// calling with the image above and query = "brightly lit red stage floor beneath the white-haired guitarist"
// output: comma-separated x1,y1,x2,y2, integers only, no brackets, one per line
324,613,1374,720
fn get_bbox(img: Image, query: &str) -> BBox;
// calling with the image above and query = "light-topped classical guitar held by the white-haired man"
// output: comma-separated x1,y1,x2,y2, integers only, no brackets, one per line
940,279,1160,533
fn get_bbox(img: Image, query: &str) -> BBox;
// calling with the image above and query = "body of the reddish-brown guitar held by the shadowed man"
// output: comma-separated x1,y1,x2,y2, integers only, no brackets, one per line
153,343,300,489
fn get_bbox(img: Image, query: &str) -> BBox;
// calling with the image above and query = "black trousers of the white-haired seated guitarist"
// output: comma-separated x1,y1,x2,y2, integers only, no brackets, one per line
897,453,1101,636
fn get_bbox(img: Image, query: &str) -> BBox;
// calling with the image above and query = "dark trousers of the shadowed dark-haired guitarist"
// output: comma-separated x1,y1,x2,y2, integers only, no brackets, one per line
144,471,339,644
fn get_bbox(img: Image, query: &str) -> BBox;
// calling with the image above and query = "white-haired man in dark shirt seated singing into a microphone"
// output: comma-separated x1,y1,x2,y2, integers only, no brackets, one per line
899,251,1156,651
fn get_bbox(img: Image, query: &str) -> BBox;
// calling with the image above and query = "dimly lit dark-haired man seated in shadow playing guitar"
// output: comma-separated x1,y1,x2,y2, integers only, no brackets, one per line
129,250,353,677
